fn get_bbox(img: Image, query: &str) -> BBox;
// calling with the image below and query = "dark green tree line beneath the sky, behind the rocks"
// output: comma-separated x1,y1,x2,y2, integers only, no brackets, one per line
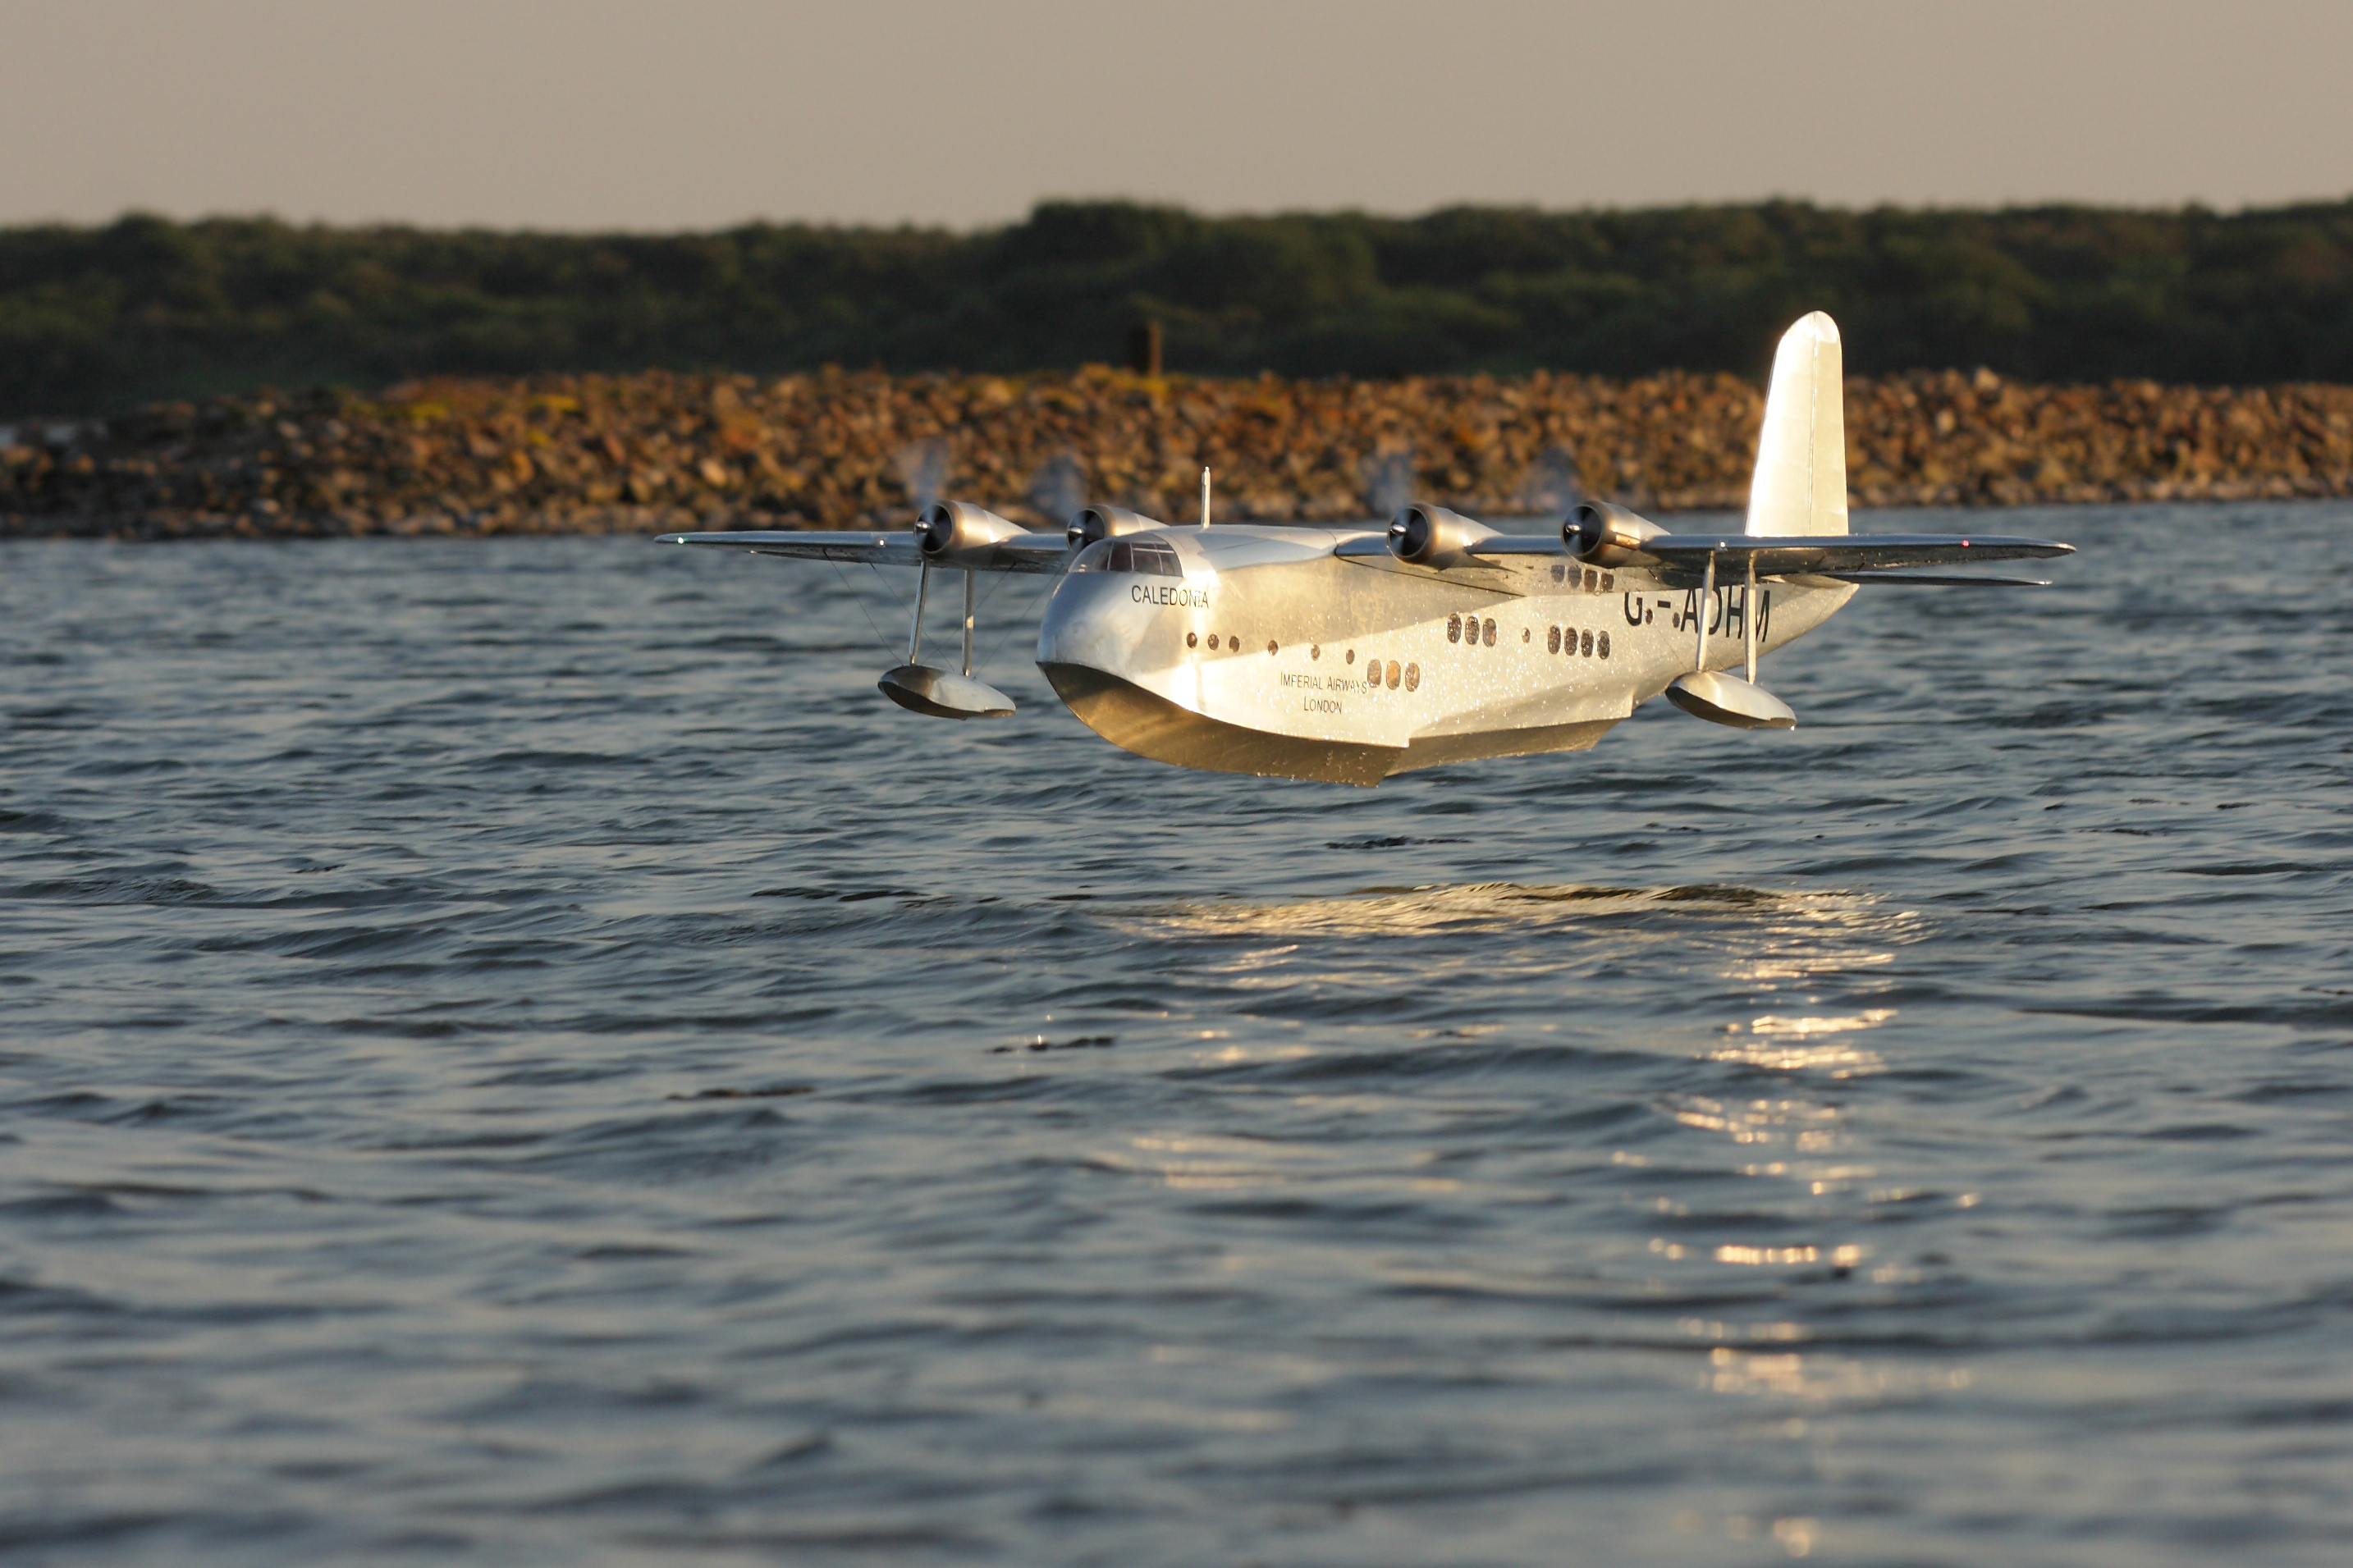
13,202,2353,418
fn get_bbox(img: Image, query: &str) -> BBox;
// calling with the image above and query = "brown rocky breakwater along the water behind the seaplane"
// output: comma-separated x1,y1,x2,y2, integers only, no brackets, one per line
0,369,2353,538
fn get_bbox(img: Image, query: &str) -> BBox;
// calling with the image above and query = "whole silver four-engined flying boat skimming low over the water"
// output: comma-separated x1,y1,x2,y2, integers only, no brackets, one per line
659,310,2073,785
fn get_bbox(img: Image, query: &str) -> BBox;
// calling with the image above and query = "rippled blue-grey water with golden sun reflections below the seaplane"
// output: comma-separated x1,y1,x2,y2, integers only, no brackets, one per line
0,505,2353,1566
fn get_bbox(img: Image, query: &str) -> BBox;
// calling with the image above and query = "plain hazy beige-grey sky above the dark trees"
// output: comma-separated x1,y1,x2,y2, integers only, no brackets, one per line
0,0,2353,228
